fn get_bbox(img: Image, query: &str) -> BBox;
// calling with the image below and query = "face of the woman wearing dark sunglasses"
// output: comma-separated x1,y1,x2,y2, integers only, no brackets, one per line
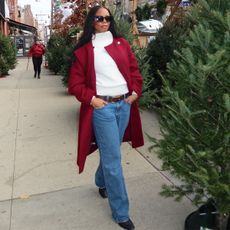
94,8,112,33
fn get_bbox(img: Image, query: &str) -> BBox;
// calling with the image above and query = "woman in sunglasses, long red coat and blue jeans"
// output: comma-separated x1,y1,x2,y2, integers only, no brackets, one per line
68,6,144,230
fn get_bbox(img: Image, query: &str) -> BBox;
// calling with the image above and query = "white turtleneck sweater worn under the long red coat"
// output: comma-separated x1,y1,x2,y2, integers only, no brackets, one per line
92,31,128,96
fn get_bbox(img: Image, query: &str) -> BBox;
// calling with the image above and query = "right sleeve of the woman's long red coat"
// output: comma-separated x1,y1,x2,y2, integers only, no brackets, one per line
127,42,143,96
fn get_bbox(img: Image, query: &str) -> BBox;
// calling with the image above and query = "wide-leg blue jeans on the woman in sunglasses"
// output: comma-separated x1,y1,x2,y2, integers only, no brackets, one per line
93,100,130,223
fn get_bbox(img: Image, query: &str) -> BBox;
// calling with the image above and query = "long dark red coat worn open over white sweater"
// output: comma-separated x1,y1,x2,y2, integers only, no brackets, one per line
68,38,144,173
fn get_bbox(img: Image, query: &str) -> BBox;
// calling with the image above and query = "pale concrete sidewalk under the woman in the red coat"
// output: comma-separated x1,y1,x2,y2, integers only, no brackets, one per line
0,58,194,230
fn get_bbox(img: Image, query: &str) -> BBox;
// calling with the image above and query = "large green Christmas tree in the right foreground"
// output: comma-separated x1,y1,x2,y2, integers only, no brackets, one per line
150,0,230,230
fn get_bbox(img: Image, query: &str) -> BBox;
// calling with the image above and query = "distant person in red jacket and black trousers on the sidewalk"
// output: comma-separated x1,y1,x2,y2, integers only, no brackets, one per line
28,39,45,79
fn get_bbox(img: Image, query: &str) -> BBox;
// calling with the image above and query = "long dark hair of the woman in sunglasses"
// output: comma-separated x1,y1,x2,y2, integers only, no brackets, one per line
75,6,121,49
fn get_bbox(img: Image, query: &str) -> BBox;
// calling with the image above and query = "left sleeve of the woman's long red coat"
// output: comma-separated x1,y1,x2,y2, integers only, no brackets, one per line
68,50,95,104
